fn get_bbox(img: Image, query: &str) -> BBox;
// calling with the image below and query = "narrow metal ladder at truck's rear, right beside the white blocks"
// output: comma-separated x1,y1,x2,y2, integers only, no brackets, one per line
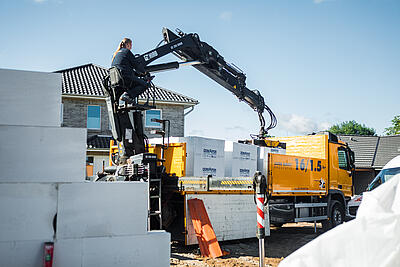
146,164,162,231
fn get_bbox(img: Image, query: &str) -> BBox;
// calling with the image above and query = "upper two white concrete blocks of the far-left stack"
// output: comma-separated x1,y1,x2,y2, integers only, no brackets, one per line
0,69,86,183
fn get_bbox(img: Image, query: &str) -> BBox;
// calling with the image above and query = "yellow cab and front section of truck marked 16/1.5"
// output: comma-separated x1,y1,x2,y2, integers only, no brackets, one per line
267,132,354,230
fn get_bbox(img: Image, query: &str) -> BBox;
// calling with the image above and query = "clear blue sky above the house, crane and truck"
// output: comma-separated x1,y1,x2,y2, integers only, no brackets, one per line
0,0,400,140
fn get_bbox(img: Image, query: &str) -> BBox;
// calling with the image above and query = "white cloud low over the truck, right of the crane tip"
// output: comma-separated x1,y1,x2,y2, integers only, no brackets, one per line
278,114,331,134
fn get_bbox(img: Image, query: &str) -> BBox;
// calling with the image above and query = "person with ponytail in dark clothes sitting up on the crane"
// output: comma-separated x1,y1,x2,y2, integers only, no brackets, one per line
111,38,150,104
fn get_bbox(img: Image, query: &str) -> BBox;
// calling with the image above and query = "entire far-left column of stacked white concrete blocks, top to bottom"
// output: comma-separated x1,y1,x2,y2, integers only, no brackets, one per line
0,69,86,266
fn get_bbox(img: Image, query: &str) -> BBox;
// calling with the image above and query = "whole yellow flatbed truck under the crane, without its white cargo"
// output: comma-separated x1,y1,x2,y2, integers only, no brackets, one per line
105,133,354,245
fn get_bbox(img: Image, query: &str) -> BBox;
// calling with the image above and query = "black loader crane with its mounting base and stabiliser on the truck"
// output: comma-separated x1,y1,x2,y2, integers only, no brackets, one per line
97,28,277,234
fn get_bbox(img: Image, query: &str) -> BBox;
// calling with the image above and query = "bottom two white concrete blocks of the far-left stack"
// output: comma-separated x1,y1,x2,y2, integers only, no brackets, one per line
0,184,57,267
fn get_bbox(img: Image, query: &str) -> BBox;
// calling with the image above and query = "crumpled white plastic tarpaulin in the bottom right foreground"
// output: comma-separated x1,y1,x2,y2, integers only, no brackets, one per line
279,174,400,267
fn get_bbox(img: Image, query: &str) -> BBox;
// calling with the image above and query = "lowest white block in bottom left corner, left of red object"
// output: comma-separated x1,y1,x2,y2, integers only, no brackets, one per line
0,240,48,267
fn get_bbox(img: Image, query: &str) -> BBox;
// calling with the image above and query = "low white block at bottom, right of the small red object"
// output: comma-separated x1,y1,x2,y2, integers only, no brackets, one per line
53,231,171,267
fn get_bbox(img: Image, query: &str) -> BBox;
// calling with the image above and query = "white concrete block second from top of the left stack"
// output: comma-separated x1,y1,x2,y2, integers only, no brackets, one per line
0,125,86,183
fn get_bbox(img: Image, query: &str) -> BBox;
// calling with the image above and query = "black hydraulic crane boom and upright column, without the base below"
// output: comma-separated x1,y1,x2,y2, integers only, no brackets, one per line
103,28,276,165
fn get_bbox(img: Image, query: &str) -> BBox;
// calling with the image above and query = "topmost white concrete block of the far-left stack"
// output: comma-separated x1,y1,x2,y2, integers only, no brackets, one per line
0,69,62,127
